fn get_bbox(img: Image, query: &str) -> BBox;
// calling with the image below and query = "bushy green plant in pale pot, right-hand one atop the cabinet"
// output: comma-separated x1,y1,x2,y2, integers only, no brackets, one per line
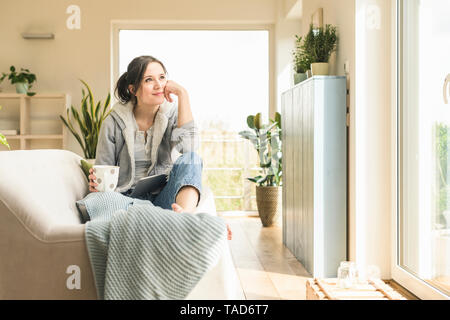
302,24,338,76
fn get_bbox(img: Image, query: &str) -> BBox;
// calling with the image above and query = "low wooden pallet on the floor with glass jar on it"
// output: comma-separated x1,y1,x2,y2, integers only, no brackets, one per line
306,278,407,300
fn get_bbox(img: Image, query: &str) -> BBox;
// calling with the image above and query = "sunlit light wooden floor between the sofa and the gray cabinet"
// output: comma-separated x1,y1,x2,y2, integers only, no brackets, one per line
224,216,311,300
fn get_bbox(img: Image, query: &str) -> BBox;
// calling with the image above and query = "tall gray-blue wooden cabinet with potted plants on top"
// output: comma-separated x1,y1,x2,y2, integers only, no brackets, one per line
281,76,347,277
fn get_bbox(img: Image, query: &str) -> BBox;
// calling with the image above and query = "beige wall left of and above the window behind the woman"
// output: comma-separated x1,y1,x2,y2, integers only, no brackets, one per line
0,0,277,154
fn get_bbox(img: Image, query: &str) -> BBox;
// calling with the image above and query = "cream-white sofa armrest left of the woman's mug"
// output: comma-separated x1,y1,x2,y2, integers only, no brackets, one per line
0,150,88,242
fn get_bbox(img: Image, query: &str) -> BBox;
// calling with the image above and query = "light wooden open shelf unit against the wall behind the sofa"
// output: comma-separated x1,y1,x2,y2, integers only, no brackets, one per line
0,92,70,150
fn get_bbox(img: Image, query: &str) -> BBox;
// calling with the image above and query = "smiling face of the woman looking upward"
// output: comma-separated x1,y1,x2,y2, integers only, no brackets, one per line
130,62,167,106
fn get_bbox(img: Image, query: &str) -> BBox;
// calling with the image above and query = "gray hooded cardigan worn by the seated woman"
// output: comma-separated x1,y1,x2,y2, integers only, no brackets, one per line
95,100,199,192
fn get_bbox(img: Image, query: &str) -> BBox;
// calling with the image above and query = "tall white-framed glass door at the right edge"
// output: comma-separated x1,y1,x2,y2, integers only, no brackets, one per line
397,0,450,295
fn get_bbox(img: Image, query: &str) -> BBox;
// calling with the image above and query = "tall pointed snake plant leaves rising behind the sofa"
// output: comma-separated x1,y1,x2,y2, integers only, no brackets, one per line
60,79,111,159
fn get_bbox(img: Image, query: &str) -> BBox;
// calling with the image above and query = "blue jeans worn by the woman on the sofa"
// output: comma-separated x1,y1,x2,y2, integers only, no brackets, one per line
124,152,203,210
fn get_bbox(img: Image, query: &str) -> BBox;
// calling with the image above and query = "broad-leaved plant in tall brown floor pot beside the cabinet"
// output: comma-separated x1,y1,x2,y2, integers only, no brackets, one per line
239,112,282,227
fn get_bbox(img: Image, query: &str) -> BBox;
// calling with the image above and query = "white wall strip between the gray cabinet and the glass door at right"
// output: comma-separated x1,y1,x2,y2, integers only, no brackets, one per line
350,0,395,278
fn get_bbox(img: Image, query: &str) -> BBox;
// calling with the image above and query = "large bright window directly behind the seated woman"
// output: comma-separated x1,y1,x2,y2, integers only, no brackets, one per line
118,29,269,211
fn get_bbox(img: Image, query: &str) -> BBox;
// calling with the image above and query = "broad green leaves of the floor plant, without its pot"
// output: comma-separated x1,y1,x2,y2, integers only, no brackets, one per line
239,112,282,186
